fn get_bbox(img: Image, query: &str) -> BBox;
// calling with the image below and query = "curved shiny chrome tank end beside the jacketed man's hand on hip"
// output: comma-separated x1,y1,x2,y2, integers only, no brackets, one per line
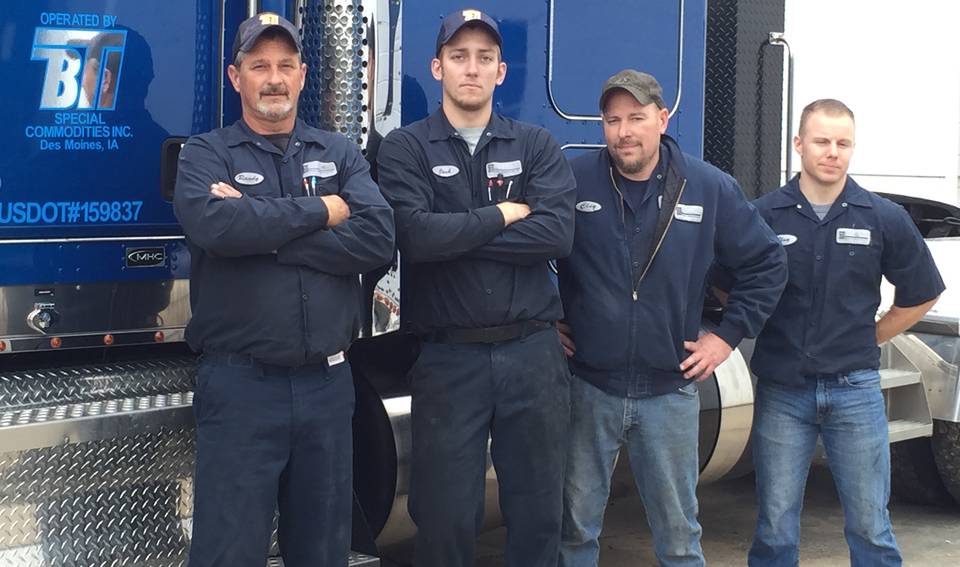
700,349,753,482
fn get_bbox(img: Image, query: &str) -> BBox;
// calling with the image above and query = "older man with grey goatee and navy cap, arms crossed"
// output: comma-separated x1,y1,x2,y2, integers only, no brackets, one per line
174,13,393,567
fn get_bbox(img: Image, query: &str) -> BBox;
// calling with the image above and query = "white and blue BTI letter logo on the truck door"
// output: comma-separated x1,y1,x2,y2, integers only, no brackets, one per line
31,28,127,110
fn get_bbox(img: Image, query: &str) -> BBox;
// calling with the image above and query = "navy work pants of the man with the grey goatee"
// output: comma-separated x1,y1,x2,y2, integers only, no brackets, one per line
189,354,354,567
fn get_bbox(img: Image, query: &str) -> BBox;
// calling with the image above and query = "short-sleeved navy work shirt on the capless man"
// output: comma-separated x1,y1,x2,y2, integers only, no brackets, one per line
751,176,944,385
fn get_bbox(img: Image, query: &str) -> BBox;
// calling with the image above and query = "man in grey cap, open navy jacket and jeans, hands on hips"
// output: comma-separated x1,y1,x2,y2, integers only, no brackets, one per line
559,69,787,567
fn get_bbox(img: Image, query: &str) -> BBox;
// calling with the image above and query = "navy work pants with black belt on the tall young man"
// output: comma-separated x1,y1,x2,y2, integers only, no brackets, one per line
410,328,570,567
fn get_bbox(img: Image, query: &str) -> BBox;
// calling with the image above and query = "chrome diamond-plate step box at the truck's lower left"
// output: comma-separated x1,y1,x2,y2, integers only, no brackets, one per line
0,357,194,567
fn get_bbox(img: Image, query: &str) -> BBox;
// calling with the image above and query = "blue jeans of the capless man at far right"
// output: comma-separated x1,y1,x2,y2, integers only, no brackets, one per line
749,370,902,567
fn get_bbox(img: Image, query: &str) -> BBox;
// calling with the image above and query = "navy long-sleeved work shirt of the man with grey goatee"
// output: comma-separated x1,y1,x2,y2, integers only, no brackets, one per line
174,120,394,367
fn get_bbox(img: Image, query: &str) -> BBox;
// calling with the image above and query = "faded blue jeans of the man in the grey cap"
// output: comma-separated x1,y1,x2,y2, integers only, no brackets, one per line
560,377,704,567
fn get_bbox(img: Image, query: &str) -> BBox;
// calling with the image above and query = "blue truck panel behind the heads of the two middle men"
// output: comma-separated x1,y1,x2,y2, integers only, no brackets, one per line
403,0,706,155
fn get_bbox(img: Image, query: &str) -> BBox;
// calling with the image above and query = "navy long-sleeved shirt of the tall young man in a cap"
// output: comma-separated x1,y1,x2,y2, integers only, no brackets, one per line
377,109,576,333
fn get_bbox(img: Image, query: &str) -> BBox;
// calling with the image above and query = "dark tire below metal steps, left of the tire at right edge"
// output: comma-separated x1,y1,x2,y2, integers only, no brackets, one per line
890,437,960,506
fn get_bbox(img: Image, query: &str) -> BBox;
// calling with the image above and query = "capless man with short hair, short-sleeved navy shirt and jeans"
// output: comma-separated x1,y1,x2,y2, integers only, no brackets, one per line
749,99,944,567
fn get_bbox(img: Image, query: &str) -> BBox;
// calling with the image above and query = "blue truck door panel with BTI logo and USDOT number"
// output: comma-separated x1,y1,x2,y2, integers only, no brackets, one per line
0,0,220,244
